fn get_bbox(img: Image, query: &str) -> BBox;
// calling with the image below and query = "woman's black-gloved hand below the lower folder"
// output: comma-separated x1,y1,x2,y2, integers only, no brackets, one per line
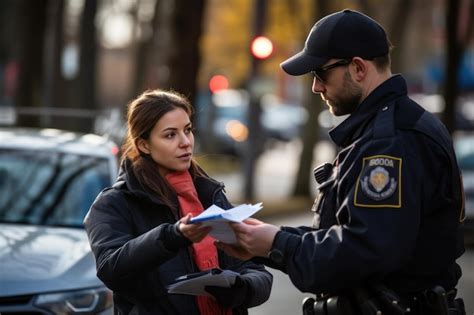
204,276,248,308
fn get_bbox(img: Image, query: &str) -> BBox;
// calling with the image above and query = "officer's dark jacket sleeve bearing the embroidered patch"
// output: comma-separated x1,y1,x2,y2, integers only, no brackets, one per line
273,133,430,293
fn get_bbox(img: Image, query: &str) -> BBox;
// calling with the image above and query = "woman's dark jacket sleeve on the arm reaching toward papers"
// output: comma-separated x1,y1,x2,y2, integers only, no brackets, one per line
84,190,190,290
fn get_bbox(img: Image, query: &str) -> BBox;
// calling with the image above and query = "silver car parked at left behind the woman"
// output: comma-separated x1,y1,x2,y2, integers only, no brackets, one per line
0,128,118,315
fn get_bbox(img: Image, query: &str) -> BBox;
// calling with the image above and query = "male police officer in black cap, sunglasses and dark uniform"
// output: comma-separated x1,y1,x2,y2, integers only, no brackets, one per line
219,10,464,314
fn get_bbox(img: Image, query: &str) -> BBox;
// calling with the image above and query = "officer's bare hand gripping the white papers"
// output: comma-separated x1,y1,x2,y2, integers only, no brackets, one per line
231,218,280,257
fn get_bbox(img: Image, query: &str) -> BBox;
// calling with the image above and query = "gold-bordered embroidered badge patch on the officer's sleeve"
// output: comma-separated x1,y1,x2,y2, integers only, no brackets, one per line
354,155,402,208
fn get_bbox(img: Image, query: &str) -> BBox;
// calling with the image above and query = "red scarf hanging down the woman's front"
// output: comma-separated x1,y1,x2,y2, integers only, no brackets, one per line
166,171,232,315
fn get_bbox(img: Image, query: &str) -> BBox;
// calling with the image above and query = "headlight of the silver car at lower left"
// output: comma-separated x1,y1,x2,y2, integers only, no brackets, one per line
34,288,113,315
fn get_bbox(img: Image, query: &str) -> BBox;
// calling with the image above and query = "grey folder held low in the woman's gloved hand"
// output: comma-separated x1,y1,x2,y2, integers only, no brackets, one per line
168,268,239,296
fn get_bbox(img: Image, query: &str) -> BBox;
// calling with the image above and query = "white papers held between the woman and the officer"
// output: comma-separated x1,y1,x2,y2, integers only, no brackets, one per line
190,202,262,244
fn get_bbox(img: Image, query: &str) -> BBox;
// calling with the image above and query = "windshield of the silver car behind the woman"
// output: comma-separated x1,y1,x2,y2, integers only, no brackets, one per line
0,149,110,227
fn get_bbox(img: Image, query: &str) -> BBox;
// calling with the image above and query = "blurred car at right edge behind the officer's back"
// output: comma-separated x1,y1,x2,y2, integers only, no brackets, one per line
454,133,474,242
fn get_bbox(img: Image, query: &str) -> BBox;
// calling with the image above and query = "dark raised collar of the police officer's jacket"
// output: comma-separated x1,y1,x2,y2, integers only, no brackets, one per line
329,74,407,147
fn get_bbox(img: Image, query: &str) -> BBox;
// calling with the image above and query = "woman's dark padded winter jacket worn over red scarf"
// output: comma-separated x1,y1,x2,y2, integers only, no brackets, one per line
84,161,272,315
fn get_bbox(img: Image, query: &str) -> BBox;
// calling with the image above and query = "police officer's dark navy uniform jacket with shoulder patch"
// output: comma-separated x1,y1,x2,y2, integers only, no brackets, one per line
264,75,464,293
